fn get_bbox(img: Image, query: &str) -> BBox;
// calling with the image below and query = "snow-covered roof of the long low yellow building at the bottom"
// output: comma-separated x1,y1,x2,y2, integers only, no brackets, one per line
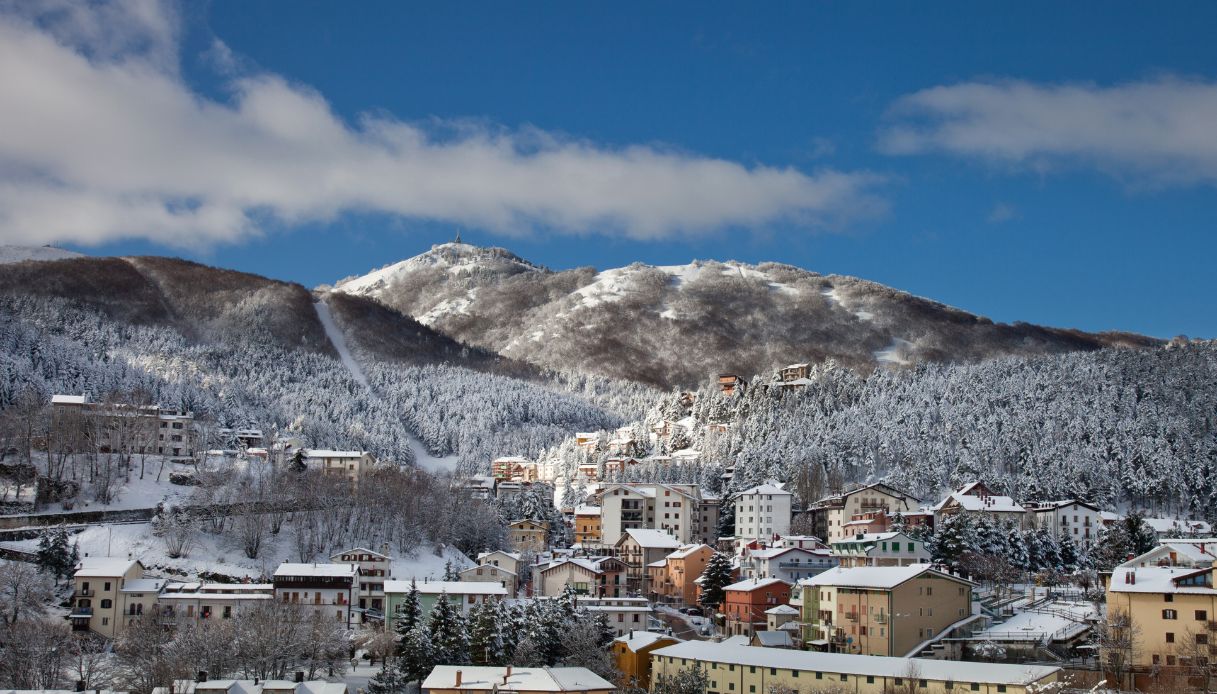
651,637,1060,685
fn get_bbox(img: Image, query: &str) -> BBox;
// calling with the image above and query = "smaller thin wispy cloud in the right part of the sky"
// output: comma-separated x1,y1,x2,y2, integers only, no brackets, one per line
879,78,1217,185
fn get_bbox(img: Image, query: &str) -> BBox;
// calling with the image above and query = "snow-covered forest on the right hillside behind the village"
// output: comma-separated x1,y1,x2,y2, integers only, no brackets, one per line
557,342,1217,520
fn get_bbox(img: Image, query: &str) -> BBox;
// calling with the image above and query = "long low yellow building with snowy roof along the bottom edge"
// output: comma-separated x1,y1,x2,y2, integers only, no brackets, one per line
651,640,1061,694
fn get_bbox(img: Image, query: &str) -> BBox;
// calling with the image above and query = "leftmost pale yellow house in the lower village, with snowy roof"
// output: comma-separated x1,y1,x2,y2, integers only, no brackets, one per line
68,556,144,638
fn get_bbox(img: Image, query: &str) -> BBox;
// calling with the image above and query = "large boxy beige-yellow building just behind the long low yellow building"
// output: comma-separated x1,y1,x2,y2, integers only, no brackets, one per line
800,564,975,656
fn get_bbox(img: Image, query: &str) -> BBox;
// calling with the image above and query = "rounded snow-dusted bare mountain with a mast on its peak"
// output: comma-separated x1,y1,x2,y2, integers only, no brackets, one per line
333,244,1160,387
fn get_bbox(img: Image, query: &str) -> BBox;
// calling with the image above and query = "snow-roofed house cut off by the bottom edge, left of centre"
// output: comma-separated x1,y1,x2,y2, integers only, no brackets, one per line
421,665,617,694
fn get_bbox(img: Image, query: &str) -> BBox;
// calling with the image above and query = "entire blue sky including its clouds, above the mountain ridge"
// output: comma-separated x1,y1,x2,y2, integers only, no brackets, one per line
0,0,1217,337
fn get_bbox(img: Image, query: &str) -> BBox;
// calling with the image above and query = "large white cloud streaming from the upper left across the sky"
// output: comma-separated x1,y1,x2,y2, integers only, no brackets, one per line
0,1,880,245
